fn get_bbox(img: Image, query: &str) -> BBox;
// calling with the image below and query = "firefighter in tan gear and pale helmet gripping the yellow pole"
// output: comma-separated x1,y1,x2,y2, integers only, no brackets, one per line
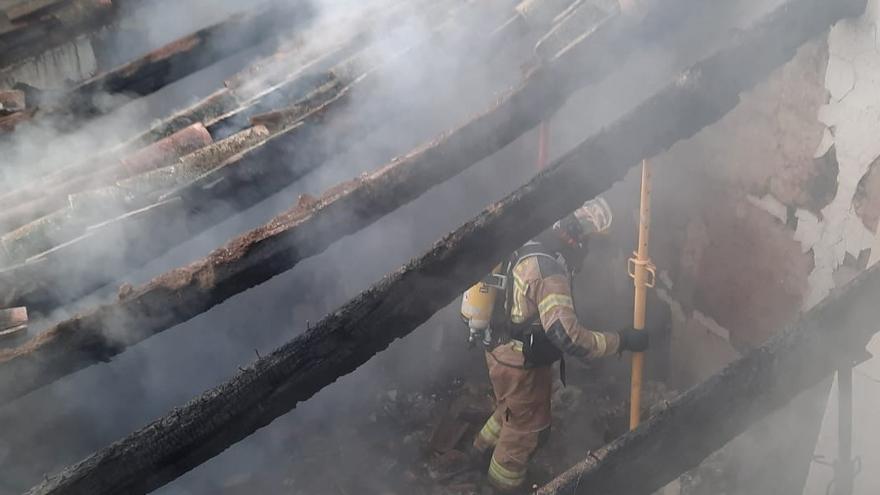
468,198,648,493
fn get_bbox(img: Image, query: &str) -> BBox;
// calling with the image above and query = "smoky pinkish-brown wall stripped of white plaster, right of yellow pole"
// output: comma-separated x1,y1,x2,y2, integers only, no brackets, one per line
648,39,836,494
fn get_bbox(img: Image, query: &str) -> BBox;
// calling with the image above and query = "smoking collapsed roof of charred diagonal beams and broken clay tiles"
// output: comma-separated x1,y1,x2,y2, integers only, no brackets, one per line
0,0,880,494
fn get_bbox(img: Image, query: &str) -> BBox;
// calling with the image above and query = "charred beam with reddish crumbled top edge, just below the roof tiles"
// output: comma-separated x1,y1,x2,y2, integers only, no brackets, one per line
0,0,632,397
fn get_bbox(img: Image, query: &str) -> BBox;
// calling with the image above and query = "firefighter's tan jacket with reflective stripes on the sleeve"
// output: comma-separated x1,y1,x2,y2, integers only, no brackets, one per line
509,246,620,360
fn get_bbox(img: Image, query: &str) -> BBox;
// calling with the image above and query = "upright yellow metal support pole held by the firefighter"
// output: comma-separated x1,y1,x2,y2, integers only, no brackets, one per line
629,160,655,429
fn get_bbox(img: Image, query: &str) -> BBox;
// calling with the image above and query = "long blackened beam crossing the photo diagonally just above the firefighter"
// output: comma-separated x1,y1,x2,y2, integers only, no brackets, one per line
17,0,864,495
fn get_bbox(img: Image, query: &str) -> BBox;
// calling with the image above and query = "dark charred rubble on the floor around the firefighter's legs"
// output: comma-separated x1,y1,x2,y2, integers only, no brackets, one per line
217,369,684,495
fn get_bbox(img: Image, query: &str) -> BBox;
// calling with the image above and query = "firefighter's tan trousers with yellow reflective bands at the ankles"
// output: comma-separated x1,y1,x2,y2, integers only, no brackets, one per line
474,341,553,491
